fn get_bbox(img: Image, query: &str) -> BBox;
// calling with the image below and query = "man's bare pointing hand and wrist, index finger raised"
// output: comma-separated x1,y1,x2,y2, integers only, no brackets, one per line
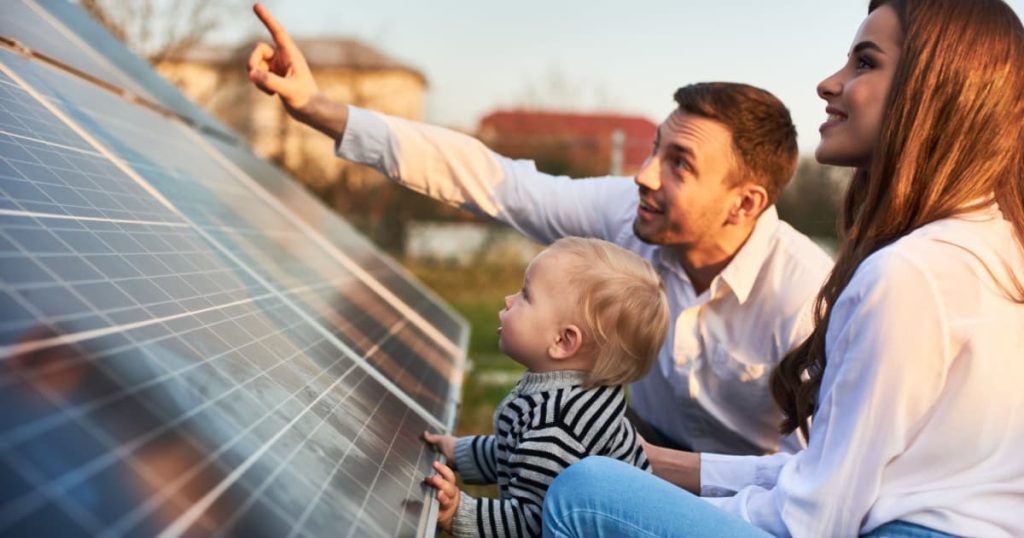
248,4,348,140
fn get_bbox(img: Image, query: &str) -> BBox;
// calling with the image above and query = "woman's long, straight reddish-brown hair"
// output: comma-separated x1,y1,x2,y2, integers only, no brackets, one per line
771,0,1024,439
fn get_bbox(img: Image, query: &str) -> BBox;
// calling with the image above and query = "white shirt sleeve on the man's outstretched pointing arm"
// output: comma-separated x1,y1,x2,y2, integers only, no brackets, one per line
336,107,638,243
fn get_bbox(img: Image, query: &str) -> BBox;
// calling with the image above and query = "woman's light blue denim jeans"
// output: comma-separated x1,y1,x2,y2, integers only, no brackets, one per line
544,456,949,538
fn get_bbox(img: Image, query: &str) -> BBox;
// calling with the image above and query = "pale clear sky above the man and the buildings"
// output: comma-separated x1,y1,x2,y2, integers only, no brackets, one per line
214,0,1024,155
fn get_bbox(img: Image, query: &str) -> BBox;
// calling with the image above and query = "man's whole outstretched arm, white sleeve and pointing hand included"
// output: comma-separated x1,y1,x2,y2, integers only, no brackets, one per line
248,4,637,243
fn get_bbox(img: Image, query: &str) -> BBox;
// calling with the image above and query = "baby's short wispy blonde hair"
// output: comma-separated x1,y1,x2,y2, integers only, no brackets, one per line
548,237,669,386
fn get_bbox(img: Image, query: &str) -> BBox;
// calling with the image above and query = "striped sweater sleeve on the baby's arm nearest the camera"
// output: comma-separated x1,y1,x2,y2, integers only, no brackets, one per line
453,424,587,537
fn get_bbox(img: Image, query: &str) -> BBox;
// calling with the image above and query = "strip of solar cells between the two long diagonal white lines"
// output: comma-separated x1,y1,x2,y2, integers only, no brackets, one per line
2,49,456,421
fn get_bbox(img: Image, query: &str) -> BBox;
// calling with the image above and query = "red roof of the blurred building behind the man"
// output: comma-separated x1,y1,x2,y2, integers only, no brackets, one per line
478,111,657,173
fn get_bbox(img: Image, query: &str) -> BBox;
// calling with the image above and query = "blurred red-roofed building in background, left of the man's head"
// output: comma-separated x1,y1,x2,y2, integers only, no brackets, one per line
477,111,657,176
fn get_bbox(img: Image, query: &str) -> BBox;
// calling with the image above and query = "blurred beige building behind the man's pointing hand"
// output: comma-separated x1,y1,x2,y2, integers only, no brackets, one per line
157,38,427,192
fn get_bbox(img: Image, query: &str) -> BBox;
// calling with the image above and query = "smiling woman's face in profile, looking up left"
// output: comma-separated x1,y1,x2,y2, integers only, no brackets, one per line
814,5,903,167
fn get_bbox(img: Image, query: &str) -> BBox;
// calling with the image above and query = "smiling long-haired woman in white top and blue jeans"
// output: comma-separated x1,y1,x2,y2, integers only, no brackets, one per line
544,0,1024,536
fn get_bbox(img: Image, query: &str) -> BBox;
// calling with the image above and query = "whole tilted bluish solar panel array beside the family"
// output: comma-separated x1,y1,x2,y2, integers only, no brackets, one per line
0,0,468,537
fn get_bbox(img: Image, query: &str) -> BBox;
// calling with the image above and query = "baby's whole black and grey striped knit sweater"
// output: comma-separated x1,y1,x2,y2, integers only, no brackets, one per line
452,371,650,538
